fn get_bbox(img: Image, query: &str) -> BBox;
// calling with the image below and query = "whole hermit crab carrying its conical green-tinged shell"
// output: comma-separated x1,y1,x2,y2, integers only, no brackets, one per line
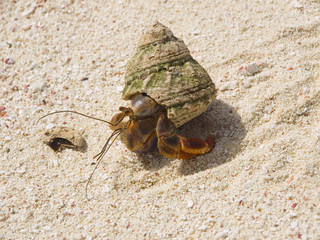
40,22,217,196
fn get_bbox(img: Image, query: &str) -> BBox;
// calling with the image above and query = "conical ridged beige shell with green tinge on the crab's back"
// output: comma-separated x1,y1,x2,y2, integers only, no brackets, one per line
122,22,216,127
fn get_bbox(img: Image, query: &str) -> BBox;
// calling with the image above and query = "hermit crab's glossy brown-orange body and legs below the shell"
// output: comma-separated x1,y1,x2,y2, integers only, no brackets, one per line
111,94,214,159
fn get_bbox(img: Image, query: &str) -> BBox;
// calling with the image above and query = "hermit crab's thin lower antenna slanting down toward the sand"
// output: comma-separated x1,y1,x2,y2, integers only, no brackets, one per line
86,120,131,201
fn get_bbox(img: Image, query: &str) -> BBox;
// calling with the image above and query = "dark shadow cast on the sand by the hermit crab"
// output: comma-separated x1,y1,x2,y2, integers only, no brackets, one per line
140,100,246,175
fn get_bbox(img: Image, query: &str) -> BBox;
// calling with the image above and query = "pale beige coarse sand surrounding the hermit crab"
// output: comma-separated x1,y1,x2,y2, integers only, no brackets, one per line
0,0,320,239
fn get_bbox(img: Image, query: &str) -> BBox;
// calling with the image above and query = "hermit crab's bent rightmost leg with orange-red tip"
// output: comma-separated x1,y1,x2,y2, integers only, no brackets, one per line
156,115,215,159
